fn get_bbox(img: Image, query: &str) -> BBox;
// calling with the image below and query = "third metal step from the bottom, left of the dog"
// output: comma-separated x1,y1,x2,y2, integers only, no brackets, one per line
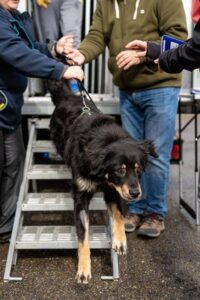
27,164,72,179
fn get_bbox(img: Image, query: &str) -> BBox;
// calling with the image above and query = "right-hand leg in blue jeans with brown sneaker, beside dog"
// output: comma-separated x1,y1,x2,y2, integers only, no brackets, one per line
137,88,179,237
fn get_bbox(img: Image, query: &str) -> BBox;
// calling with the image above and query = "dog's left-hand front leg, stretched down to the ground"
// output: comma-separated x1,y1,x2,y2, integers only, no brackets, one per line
74,192,92,283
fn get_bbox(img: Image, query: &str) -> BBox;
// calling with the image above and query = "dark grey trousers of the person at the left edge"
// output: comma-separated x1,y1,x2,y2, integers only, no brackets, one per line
0,126,25,235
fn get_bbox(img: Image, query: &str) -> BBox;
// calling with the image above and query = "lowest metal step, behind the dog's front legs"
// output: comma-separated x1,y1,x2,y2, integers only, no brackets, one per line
15,226,111,249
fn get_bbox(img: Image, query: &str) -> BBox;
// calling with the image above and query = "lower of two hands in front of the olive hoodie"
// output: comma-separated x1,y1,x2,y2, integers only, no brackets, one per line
116,50,140,70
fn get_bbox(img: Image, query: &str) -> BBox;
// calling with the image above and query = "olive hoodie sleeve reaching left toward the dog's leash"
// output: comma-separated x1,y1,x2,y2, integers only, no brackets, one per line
78,1,105,63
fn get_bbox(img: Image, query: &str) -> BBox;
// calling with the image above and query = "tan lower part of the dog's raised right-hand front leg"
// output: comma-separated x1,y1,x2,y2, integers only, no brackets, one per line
110,203,127,255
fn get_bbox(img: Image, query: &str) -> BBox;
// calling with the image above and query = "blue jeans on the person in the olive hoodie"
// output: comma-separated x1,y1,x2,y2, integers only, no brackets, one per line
120,87,180,216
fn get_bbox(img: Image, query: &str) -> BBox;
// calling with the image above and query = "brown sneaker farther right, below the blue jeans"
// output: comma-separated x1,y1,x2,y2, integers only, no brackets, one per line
137,213,165,237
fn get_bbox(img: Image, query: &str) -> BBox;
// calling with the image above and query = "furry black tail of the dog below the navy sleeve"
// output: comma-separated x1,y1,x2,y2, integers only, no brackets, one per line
47,79,72,106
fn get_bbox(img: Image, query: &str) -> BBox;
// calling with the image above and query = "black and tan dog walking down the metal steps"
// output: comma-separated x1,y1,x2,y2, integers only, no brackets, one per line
49,82,157,283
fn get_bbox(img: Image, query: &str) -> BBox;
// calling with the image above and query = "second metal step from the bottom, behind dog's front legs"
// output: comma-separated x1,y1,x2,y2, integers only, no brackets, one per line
22,193,106,212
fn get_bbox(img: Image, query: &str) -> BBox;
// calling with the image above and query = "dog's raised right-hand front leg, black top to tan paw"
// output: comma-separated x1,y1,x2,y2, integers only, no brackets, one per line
104,190,127,255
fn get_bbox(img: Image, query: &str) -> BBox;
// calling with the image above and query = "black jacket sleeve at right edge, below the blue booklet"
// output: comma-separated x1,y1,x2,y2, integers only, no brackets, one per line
159,20,200,73
